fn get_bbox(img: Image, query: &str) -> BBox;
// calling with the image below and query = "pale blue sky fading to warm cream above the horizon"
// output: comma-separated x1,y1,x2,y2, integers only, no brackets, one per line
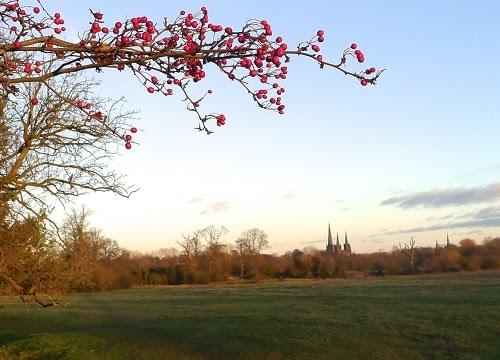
47,0,500,253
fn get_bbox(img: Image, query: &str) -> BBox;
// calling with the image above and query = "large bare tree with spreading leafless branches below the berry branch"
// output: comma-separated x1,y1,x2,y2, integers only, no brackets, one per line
0,75,135,229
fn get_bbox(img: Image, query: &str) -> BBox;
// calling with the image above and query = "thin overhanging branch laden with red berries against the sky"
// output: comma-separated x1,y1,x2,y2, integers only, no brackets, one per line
0,0,384,141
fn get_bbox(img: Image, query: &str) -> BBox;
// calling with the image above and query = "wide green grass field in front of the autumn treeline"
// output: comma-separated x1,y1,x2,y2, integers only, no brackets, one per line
0,272,500,360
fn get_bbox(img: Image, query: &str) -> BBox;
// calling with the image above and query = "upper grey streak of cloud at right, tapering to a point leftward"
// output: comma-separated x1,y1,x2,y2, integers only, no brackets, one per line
380,183,500,209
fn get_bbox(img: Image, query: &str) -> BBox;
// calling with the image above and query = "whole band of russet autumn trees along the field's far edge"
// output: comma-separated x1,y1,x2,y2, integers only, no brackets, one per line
0,210,500,305
